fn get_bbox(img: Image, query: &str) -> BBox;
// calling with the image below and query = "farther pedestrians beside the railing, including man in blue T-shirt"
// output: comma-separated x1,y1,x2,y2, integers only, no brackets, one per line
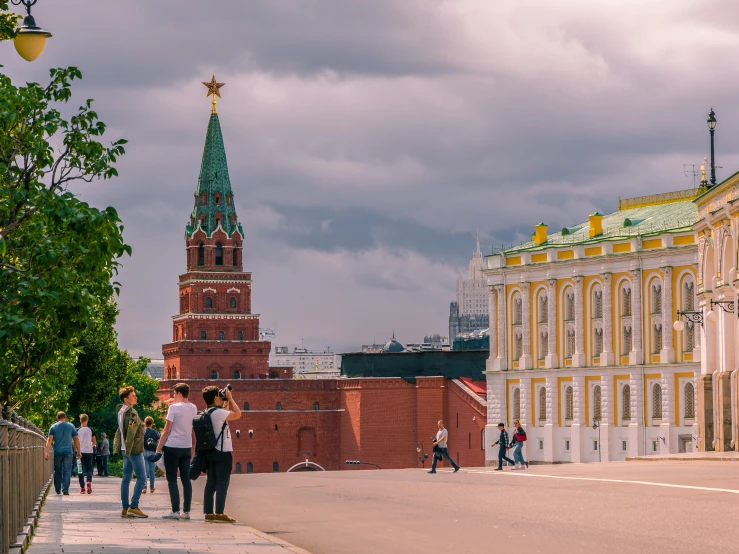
44,412,110,495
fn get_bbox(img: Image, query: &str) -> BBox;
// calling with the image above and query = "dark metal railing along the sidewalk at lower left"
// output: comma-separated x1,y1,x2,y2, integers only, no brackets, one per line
0,407,54,554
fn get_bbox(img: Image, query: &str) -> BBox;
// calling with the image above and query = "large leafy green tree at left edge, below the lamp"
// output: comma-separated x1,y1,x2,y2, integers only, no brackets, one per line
0,64,131,417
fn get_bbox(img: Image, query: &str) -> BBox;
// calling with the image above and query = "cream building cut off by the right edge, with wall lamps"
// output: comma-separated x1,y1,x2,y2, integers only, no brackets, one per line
694,169,739,452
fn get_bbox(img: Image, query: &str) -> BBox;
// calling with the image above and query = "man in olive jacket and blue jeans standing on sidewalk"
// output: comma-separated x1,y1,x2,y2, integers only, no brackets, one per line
113,387,149,518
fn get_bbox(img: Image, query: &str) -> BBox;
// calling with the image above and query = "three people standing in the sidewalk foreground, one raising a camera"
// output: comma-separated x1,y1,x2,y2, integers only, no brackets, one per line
113,383,241,523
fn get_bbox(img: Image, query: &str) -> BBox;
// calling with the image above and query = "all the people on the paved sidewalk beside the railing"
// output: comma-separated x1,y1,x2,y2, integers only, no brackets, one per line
45,383,241,523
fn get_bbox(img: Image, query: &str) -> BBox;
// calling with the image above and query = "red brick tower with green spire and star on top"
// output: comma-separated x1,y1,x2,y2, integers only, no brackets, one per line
162,77,270,380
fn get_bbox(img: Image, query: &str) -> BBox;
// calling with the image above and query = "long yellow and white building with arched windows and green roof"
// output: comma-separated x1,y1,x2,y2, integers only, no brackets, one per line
484,189,704,464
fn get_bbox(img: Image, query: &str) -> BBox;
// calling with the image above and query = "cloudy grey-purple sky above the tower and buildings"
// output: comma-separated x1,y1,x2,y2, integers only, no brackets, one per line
5,0,739,357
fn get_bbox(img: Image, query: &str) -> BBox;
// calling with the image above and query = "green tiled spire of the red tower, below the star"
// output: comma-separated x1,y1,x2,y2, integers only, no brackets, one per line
187,113,244,237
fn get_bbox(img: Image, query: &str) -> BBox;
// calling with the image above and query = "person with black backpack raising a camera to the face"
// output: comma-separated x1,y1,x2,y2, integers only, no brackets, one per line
201,386,241,523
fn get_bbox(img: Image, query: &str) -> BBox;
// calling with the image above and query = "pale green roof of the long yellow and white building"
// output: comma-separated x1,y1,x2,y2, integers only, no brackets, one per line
504,198,698,254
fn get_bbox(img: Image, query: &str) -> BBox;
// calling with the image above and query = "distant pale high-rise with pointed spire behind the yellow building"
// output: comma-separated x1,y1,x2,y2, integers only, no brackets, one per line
449,232,489,342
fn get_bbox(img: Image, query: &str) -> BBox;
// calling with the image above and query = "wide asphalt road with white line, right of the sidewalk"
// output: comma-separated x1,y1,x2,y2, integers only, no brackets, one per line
195,461,739,554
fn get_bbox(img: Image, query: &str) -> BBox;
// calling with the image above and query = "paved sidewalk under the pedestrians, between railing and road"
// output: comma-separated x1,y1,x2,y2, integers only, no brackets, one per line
28,477,309,554
